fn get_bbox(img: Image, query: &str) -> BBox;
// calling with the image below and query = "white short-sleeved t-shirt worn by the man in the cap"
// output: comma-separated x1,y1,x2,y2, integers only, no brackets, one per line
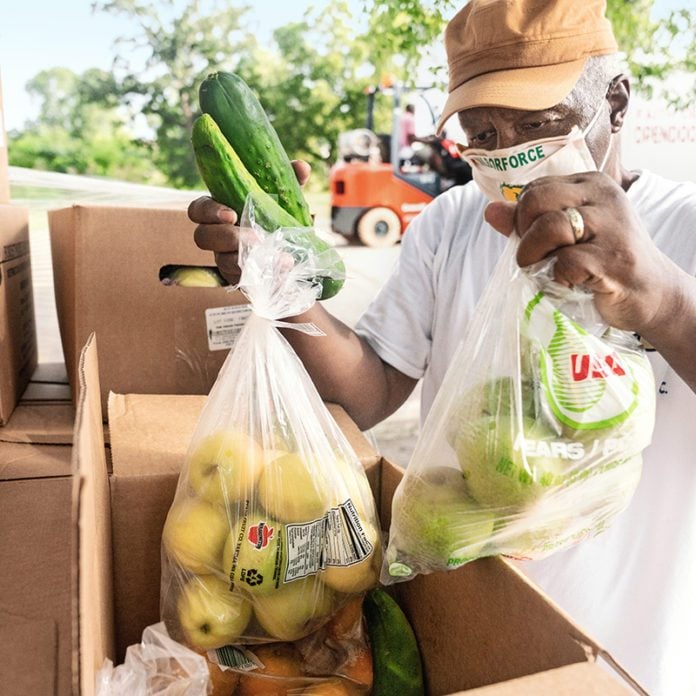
357,171,696,696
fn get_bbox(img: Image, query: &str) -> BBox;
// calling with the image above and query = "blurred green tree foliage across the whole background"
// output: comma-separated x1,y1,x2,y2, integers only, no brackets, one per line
10,0,696,188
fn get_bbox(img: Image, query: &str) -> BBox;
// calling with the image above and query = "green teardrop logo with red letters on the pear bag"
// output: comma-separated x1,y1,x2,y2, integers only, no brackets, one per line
525,293,645,430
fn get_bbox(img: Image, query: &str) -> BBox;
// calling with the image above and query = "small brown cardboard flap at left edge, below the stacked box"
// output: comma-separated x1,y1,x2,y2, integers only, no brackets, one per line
0,402,75,445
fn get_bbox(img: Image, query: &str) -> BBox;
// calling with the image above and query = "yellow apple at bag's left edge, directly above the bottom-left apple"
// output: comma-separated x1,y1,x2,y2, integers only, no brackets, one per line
162,498,230,575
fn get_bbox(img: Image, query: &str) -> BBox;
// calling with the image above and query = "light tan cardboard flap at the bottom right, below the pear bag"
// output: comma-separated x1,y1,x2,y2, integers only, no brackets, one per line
460,662,632,696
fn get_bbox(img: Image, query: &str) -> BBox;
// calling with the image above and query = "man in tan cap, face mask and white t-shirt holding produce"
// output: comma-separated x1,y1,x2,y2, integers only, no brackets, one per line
190,0,696,696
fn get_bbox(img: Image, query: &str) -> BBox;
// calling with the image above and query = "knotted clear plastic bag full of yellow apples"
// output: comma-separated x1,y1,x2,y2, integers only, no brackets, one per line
160,197,382,650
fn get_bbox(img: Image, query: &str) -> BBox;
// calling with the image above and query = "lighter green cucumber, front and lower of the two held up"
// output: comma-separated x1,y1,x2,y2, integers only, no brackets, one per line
191,114,346,300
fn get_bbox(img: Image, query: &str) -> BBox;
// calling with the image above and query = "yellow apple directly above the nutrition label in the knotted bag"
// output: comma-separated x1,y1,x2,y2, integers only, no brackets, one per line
257,454,329,522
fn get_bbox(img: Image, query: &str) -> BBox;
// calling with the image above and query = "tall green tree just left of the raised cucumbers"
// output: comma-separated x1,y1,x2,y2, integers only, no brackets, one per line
93,0,255,188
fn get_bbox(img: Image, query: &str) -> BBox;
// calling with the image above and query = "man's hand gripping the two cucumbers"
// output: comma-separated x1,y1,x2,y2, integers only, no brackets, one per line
188,160,311,285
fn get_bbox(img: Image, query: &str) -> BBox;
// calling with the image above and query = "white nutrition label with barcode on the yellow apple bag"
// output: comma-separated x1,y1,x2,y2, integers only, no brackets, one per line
285,499,373,582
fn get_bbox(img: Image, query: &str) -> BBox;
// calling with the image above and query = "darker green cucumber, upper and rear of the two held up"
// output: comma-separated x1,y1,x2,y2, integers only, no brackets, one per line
199,72,312,227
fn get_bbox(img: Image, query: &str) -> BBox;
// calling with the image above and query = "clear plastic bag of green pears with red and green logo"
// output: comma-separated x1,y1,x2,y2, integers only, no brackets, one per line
382,237,655,583
